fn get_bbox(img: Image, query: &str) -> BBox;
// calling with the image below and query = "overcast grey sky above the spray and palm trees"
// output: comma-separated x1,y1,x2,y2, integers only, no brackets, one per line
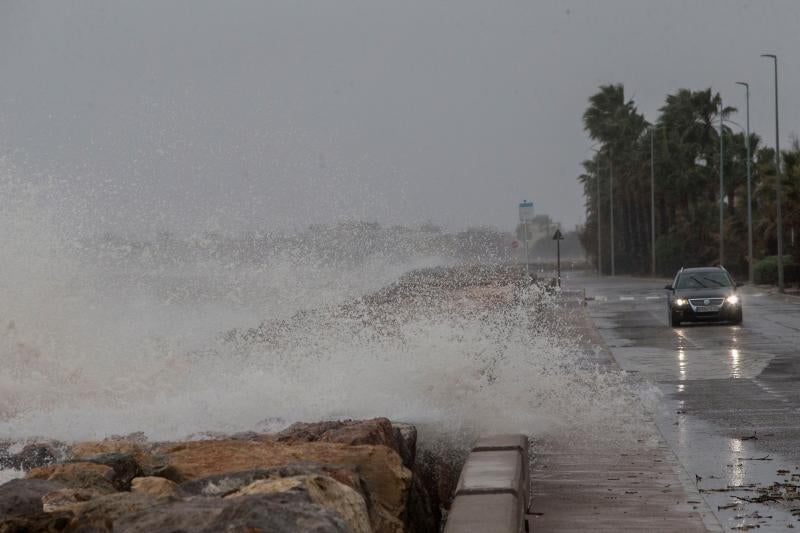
0,0,800,230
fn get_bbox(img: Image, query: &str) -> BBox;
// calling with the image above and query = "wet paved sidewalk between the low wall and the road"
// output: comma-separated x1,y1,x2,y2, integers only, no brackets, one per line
531,306,722,532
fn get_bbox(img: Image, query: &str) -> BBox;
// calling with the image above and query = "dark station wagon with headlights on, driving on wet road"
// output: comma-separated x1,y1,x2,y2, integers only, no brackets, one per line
664,267,742,327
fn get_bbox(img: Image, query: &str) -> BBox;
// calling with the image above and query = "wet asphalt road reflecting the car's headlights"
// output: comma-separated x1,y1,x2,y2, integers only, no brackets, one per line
565,274,800,531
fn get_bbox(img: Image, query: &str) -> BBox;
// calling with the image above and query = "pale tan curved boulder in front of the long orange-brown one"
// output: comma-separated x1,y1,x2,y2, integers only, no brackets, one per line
227,475,372,533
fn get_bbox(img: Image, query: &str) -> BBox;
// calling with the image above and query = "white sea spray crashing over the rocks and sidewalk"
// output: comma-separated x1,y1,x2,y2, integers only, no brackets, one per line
0,169,639,454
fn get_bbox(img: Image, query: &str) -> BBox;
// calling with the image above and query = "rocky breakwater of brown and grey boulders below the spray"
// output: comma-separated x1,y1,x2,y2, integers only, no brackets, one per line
0,418,439,533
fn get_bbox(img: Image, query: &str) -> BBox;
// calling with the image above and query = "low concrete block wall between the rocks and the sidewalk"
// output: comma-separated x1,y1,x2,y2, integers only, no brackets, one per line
444,434,530,533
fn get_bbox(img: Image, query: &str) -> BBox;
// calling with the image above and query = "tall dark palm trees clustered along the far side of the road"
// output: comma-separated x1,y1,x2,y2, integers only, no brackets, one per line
578,84,800,275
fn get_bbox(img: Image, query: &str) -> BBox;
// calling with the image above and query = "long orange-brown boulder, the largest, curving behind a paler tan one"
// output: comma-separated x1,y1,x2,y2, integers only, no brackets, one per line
157,440,411,532
